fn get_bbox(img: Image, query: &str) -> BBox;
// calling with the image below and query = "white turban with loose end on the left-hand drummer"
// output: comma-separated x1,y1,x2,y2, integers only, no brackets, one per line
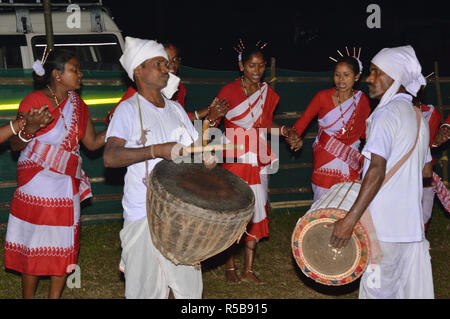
119,37,180,99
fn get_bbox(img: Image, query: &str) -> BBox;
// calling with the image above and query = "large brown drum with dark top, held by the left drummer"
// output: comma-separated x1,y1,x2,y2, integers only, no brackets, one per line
147,160,255,265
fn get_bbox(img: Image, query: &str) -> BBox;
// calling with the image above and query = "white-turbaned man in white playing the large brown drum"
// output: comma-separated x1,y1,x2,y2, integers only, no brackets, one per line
103,37,213,299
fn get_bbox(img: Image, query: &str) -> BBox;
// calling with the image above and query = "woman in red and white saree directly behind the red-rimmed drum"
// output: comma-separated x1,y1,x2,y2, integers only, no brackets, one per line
294,57,370,201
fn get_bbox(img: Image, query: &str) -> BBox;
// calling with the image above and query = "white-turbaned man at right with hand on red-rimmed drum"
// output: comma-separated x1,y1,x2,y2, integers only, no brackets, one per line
330,46,434,299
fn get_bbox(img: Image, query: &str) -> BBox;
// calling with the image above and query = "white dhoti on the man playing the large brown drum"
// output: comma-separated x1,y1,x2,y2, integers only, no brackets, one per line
120,218,203,299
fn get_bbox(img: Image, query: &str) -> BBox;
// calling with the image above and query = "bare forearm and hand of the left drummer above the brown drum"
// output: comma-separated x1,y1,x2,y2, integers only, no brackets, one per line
103,137,183,167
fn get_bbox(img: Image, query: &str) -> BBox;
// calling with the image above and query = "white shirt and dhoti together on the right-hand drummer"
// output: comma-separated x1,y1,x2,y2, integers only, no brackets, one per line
360,94,434,298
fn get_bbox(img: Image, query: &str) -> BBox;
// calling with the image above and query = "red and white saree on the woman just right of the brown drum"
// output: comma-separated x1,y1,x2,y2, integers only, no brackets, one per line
217,79,279,241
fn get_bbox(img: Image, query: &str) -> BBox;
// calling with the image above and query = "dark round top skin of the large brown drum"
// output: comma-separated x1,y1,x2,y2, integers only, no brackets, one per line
152,160,254,213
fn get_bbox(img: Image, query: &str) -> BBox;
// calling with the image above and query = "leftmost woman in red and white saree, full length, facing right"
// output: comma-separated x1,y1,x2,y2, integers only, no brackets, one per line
5,50,105,298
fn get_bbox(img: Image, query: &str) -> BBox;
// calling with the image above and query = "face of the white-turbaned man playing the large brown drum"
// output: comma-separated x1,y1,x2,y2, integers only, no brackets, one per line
134,56,169,90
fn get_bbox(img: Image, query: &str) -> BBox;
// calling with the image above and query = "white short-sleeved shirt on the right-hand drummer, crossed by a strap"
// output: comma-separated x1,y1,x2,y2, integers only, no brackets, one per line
362,94,431,242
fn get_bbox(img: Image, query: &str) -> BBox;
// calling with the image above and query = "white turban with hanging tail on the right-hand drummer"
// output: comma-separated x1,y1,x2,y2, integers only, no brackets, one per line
371,45,427,107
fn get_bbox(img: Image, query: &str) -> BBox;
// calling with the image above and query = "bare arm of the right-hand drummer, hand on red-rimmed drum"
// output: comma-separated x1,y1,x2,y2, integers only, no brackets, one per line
330,153,386,249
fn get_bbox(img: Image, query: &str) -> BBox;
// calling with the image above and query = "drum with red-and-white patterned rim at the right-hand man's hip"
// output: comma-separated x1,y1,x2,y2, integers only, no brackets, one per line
291,182,369,286
